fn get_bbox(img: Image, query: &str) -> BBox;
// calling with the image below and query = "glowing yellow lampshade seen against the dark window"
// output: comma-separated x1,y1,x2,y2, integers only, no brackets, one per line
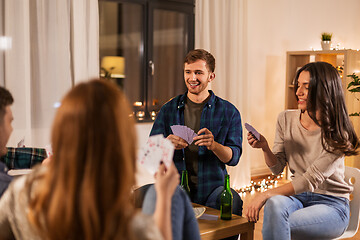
101,56,125,78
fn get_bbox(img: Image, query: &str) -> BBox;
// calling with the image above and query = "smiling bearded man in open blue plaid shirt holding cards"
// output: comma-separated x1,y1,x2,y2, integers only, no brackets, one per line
150,49,242,215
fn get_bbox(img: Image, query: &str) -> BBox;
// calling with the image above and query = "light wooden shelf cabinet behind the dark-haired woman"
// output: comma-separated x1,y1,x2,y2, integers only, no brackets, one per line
285,50,360,167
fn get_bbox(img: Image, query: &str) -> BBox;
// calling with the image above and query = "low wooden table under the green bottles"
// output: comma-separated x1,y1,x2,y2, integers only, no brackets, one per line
193,203,255,240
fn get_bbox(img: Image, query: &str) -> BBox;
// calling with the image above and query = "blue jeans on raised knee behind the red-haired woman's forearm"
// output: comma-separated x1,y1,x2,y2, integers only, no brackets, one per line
142,185,200,240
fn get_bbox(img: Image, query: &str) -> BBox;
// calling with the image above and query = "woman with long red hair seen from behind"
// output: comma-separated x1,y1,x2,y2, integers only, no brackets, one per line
0,80,199,240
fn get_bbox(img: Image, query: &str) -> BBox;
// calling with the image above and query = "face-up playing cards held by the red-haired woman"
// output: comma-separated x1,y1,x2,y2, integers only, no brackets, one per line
137,134,174,174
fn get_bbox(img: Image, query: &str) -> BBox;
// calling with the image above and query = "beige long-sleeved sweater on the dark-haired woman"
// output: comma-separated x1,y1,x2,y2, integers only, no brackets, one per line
270,110,352,198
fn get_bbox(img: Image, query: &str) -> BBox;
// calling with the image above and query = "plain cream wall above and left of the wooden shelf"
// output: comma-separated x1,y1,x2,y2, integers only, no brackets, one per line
246,0,360,174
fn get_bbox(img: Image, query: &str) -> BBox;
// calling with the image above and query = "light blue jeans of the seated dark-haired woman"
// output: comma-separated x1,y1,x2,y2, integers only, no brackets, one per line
262,192,350,240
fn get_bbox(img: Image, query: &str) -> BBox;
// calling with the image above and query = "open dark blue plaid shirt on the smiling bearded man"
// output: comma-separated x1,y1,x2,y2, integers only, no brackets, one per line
150,91,242,204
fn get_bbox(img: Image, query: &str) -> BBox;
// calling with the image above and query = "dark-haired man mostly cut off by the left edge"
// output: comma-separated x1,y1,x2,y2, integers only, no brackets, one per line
0,87,14,197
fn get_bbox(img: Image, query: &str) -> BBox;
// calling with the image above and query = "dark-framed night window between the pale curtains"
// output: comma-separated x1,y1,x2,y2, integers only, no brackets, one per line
99,0,194,121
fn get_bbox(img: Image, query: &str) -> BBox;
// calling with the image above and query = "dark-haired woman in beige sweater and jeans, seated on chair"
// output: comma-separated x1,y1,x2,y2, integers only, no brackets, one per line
244,62,359,240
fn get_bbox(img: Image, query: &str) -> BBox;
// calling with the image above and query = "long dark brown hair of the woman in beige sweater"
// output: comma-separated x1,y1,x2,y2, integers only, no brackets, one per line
295,62,359,156
